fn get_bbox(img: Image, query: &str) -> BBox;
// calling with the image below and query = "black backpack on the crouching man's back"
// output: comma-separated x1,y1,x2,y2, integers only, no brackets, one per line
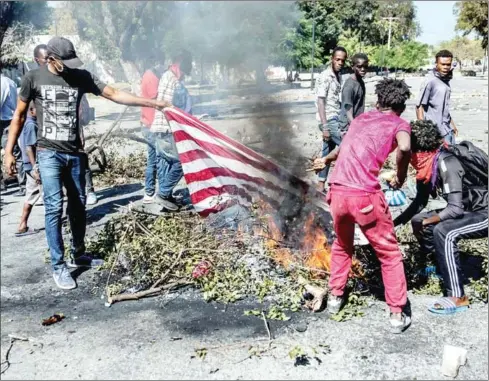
445,140,488,189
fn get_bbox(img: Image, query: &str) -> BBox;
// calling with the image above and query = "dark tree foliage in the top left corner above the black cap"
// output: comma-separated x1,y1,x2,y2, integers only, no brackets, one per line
0,1,49,66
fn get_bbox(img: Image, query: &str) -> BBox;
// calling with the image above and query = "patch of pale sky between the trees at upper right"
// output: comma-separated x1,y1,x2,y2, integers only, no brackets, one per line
414,1,457,45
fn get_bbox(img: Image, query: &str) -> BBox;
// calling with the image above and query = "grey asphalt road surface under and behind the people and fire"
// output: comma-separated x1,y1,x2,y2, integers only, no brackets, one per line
1,78,488,379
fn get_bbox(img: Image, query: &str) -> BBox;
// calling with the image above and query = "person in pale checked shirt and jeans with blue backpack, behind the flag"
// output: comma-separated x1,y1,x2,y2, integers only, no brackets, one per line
151,50,192,211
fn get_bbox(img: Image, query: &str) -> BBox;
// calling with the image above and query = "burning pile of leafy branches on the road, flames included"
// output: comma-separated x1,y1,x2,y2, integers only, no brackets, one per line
89,194,487,314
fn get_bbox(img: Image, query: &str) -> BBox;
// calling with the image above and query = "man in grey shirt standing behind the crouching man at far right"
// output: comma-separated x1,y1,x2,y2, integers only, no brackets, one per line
416,50,458,144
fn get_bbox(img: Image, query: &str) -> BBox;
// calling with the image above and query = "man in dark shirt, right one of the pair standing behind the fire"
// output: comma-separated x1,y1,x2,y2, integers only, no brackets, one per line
339,53,368,135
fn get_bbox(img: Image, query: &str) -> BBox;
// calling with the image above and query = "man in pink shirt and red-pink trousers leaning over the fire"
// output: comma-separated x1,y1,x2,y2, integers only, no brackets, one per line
314,79,411,333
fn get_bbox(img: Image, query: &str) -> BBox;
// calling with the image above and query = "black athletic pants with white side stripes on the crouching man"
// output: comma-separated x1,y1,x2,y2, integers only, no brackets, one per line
411,209,488,297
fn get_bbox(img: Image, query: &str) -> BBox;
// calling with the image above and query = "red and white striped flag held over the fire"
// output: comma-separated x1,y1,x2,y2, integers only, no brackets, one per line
164,108,309,217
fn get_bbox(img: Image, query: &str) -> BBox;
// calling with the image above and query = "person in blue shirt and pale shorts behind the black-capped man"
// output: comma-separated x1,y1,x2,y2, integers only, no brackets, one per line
15,102,41,237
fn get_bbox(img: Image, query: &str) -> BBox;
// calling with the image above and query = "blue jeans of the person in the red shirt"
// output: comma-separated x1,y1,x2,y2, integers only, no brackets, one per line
155,132,183,198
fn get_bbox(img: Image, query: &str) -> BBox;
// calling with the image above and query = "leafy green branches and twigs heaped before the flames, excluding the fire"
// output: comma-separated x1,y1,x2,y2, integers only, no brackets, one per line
89,211,321,314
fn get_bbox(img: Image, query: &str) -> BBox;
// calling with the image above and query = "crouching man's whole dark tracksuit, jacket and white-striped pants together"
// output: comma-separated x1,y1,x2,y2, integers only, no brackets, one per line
394,152,488,297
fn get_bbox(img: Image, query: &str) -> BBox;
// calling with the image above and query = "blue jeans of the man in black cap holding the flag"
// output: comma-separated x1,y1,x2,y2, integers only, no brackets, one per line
37,149,87,270
